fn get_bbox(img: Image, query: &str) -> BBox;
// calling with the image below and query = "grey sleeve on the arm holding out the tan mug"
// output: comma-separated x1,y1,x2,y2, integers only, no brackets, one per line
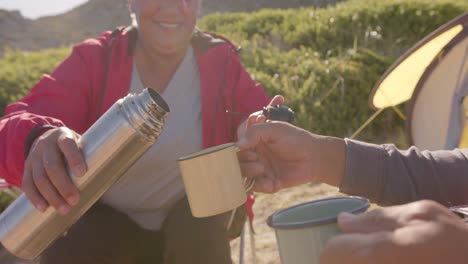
340,139,468,206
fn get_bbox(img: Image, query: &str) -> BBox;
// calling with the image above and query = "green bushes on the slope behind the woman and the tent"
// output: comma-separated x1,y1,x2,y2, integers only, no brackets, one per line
0,0,468,145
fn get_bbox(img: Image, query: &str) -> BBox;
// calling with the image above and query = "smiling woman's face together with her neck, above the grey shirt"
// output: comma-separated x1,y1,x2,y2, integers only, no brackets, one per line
128,0,201,73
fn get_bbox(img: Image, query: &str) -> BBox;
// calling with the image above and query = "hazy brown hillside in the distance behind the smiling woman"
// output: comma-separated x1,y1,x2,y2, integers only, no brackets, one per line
0,0,338,54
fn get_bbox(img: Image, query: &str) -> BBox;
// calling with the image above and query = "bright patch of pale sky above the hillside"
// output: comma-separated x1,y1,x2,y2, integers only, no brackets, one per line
0,0,88,19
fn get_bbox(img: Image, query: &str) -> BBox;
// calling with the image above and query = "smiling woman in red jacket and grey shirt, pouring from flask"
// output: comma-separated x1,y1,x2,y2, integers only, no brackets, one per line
0,0,274,264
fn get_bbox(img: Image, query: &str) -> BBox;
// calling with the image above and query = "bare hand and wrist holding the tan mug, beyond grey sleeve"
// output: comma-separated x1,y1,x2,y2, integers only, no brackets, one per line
237,121,345,193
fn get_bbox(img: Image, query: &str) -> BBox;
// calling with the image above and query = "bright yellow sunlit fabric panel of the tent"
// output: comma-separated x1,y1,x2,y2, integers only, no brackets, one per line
370,25,463,109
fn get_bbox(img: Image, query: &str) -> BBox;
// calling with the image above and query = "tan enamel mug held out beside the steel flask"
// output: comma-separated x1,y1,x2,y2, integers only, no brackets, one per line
178,143,253,217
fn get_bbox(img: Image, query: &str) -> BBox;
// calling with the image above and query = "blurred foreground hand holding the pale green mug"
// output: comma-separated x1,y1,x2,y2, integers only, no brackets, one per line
321,201,468,264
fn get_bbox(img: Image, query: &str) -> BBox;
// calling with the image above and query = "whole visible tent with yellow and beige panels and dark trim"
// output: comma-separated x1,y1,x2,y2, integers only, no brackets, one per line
369,13,468,149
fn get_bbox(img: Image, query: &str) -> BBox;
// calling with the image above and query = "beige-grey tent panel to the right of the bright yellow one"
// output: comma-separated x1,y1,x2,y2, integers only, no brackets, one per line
406,34,468,150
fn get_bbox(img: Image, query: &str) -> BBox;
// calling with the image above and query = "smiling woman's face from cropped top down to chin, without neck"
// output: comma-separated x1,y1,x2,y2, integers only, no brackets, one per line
129,0,201,54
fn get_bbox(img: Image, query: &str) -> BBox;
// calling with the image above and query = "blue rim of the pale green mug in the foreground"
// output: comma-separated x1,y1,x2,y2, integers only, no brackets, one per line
267,196,370,229
